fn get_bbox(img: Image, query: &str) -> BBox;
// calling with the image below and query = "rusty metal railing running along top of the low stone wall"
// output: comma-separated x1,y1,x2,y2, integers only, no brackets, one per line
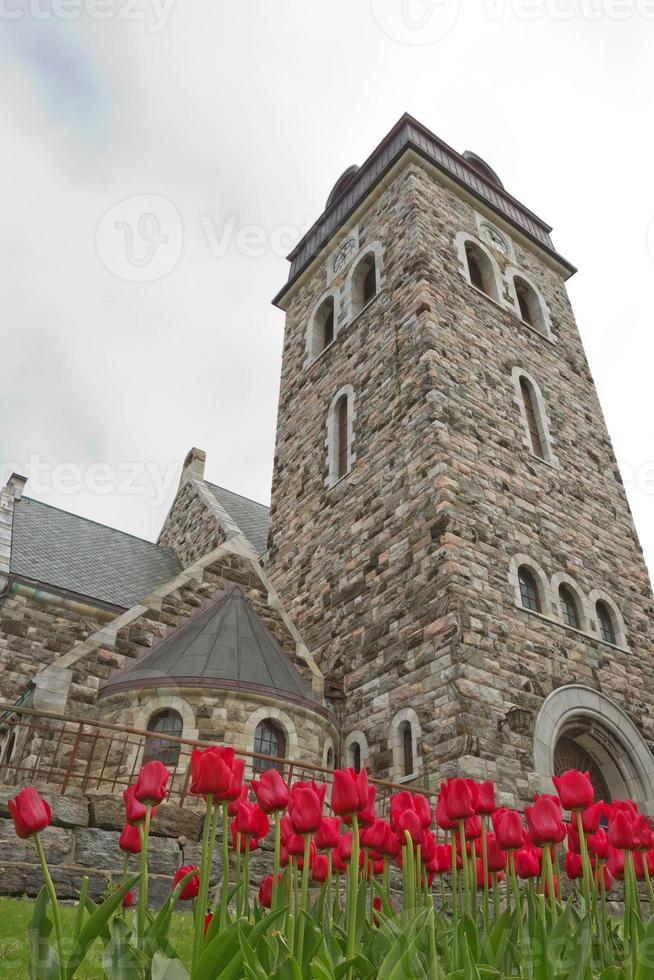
0,702,430,816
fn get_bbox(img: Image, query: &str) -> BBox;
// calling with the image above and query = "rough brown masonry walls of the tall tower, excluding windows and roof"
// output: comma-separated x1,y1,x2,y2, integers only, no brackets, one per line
269,157,654,802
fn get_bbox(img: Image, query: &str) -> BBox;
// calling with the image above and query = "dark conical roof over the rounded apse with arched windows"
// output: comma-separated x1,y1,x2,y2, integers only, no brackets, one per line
102,587,316,707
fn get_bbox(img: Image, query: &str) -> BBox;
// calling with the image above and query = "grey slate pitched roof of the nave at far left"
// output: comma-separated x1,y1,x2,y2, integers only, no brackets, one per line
10,497,182,608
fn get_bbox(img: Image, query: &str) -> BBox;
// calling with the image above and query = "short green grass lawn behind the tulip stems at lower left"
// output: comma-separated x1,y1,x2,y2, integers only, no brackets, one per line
0,898,193,980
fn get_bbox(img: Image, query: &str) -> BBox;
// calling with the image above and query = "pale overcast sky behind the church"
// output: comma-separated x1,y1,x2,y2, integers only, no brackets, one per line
0,0,654,569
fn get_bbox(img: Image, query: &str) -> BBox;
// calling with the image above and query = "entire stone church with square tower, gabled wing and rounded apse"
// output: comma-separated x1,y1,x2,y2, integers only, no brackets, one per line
0,115,654,812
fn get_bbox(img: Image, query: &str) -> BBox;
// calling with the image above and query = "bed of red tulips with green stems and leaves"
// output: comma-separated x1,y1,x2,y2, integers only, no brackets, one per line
9,747,654,980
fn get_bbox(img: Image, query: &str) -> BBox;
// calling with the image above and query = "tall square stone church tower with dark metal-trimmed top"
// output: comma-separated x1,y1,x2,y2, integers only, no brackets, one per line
269,116,654,811
